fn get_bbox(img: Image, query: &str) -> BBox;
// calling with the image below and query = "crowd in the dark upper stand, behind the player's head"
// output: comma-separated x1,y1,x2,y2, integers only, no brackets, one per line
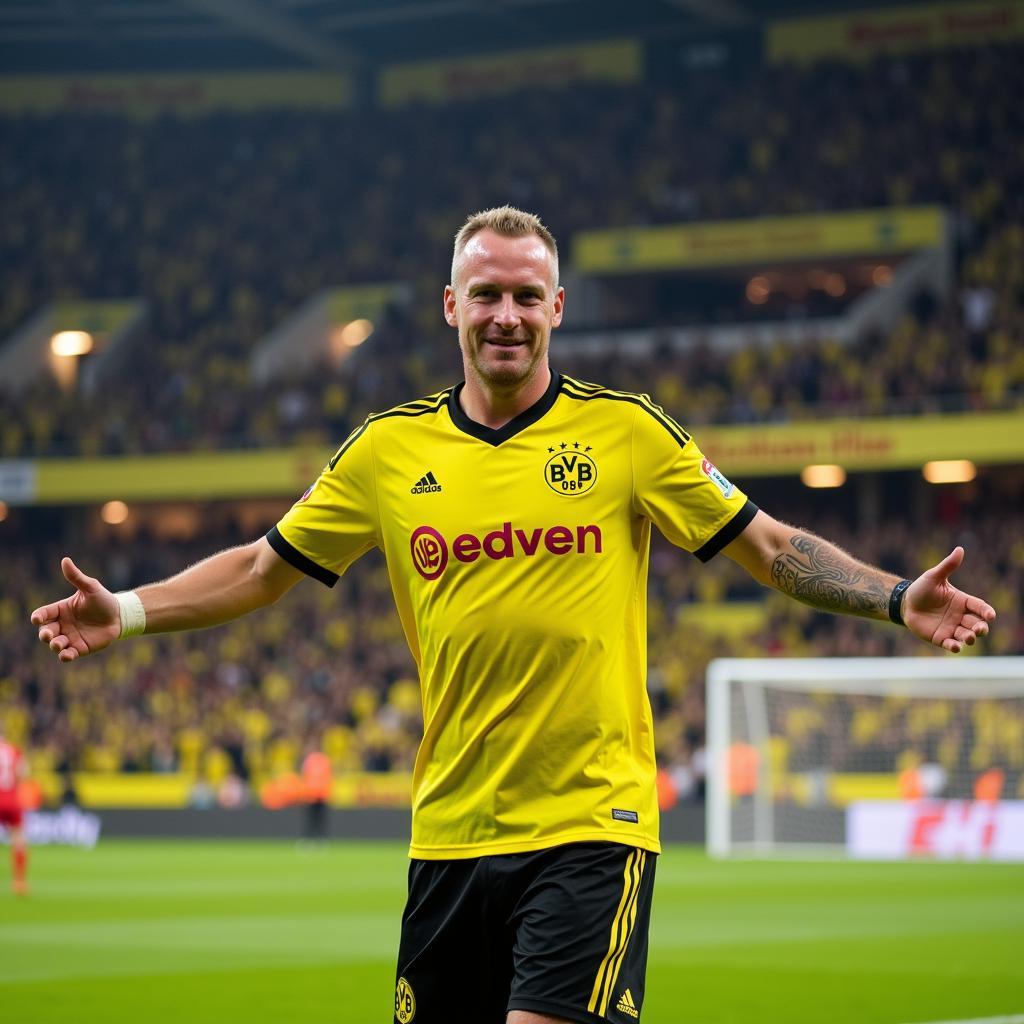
0,44,1024,457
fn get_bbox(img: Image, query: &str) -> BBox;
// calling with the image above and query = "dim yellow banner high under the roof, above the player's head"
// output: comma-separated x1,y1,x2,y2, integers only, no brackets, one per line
377,39,643,106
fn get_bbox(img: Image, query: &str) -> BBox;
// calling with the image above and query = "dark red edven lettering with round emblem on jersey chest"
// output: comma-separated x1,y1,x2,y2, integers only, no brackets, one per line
410,522,601,580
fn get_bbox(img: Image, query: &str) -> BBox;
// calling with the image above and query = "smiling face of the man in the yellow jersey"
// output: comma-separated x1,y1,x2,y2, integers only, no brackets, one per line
444,230,565,391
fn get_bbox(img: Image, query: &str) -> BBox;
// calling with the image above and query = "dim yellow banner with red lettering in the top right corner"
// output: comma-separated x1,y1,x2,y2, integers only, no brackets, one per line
765,0,1024,61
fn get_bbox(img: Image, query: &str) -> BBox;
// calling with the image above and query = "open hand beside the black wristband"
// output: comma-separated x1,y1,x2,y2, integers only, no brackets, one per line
903,547,995,654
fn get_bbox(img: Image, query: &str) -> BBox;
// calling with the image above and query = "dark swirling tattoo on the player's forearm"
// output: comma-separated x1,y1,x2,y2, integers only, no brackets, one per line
771,534,892,616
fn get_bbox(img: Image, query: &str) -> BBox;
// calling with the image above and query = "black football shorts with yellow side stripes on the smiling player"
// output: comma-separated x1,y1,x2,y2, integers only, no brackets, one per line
394,843,656,1024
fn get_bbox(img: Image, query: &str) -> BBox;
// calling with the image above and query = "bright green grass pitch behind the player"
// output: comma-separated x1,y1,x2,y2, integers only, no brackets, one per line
0,841,1024,1024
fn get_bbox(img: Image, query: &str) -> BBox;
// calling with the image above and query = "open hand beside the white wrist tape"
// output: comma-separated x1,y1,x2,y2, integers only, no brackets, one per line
32,558,121,662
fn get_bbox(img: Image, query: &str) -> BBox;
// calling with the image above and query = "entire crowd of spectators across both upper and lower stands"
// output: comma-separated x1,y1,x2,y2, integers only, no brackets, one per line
0,37,1024,788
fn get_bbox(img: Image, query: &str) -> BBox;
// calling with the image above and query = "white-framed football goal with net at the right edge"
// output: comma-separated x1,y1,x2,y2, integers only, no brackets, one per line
707,657,1024,860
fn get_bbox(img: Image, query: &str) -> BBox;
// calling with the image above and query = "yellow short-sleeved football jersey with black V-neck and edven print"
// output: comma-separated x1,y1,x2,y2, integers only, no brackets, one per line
267,374,757,859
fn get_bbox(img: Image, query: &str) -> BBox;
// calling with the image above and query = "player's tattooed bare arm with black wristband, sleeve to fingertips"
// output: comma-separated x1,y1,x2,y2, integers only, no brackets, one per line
723,512,995,653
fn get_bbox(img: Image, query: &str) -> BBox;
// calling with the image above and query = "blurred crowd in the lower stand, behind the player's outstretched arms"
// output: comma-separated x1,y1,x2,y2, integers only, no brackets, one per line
0,493,1024,790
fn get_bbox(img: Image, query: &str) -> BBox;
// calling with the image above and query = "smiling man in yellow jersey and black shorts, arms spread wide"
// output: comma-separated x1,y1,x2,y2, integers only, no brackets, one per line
32,207,995,1024
